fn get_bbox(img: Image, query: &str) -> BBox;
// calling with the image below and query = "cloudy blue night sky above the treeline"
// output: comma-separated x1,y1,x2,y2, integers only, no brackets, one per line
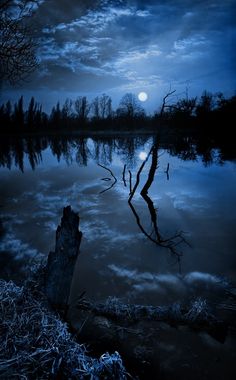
1,0,236,111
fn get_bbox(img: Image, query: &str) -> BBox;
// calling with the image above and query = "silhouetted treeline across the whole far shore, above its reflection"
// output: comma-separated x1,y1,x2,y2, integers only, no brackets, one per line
0,91,236,138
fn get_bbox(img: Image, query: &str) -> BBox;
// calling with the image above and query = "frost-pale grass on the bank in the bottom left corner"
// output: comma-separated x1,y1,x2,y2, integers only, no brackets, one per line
0,280,126,380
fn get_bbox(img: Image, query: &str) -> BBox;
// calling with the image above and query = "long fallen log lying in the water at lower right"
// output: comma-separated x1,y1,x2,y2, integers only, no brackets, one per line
77,298,228,343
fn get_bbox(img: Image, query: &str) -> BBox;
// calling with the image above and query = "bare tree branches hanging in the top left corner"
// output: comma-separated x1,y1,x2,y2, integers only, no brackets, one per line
0,0,40,85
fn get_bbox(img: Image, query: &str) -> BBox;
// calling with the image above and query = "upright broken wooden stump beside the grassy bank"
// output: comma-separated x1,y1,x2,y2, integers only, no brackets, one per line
45,206,82,310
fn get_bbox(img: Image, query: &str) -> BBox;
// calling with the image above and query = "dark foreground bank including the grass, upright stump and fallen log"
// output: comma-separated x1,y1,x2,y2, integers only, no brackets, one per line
0,206,236,380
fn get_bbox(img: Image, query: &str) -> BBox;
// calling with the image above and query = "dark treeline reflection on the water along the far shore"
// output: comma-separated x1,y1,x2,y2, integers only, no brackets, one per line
0,134,236,172
